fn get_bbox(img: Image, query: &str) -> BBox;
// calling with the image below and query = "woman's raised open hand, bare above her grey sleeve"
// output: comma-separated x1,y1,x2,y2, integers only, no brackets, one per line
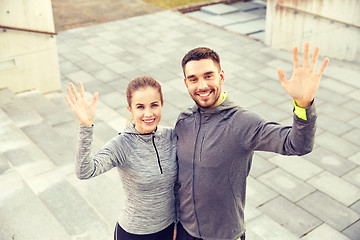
65,82,99,126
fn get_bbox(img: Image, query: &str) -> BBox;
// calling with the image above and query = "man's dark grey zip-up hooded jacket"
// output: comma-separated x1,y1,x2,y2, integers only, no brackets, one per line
175,99,316,240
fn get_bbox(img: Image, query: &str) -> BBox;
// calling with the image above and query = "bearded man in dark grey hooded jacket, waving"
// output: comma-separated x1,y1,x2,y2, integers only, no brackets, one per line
175,43,329,240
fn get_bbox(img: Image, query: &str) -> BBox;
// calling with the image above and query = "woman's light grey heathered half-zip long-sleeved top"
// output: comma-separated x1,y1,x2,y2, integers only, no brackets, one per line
76,126,177,234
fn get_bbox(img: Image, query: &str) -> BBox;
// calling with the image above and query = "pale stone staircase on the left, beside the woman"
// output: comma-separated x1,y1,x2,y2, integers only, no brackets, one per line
0,89,126,240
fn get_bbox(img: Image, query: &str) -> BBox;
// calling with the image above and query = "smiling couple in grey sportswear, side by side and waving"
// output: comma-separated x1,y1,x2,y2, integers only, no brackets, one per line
65,43,328,240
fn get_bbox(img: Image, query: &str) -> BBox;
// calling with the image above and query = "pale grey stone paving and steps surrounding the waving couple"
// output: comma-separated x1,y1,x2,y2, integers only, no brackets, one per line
0,0,360,240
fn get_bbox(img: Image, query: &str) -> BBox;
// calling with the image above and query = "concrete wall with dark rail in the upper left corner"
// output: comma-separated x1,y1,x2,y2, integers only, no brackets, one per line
0,0,61,93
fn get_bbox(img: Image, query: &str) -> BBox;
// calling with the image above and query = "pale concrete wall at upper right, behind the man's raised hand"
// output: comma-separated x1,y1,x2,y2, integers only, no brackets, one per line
265,0,360,63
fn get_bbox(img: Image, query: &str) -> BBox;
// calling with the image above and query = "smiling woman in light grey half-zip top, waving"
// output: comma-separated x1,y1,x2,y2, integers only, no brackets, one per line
65,76,177,240
